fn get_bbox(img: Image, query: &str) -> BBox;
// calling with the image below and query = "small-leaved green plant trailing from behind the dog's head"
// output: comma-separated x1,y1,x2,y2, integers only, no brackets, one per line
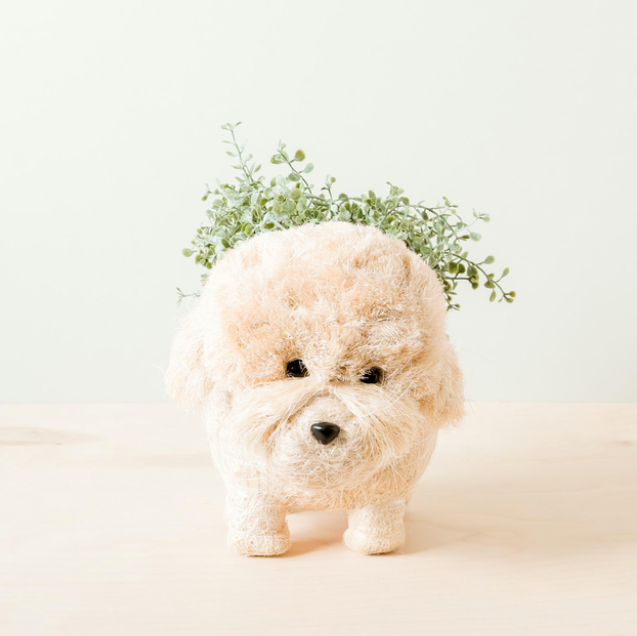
177,122,515,309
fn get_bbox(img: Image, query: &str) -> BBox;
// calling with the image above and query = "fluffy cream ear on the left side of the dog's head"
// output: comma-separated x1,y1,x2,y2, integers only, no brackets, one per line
165,314,212,412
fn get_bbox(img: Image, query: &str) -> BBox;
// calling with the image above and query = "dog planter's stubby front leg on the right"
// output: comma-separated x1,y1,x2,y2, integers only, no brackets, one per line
343,499,405,554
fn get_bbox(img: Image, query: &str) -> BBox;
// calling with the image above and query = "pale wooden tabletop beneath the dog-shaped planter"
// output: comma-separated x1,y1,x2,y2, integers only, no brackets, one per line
0,403,637,636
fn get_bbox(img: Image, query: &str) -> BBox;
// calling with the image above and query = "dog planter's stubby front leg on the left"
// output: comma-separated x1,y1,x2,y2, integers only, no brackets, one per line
226,490,290,556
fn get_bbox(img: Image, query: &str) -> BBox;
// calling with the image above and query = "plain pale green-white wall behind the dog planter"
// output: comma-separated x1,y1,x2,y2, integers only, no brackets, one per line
0,0,637,402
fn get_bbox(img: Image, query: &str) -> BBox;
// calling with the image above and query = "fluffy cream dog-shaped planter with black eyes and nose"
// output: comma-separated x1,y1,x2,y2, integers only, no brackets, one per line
166,222,463,555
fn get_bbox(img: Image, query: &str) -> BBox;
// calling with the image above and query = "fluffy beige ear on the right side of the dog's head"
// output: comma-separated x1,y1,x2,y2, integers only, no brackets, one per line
427,342,465,427
